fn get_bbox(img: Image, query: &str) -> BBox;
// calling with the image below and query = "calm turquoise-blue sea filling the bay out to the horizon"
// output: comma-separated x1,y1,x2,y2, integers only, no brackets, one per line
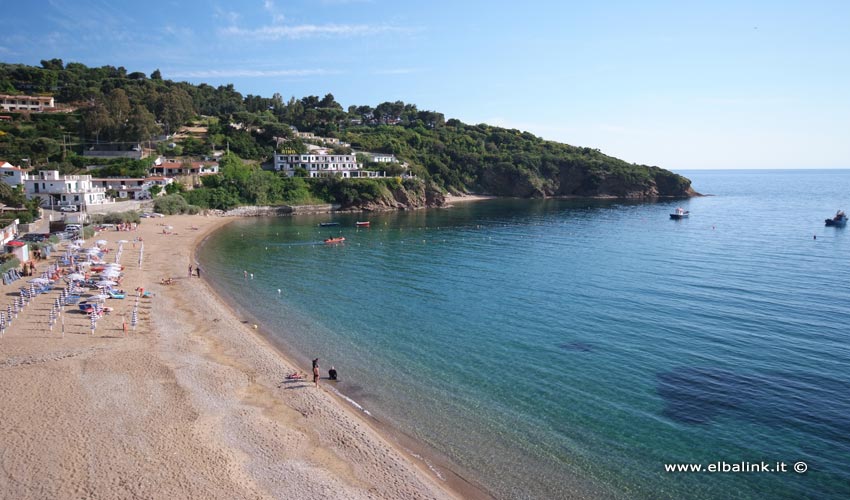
200,171,850,499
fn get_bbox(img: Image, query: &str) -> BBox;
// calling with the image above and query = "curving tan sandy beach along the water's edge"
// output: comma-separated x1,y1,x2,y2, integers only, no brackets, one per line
0,216,476,499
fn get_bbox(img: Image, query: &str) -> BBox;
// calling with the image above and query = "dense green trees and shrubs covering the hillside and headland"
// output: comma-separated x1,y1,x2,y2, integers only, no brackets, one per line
0,59,690,208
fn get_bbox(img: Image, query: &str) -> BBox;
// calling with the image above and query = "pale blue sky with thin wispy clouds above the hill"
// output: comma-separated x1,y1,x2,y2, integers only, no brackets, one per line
0,0,850,171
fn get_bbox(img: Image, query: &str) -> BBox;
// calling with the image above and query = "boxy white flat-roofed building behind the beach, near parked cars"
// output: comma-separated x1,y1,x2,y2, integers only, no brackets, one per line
24,170,110,210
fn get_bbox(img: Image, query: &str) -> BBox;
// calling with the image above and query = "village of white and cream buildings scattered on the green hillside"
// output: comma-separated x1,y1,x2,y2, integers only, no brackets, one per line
0,95,410,262
